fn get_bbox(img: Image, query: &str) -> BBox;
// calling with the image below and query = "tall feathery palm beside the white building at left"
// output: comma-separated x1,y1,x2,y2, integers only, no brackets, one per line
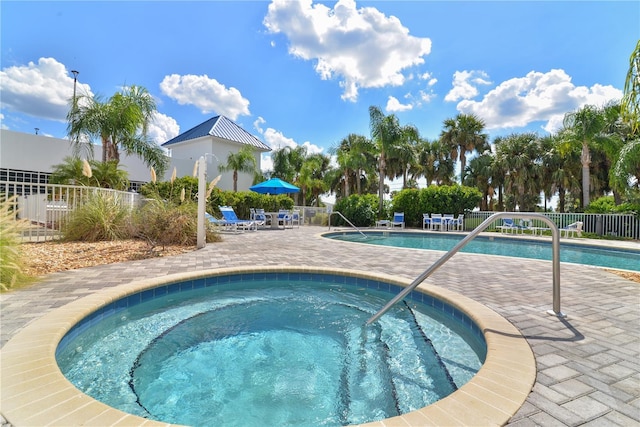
67,86,169,174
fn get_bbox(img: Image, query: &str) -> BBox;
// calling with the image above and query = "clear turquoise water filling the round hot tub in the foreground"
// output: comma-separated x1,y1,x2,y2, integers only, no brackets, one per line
56,273,486,427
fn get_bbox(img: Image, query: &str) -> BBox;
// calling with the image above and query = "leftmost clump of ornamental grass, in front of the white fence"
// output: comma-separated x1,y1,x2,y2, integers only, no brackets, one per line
62,192,131,242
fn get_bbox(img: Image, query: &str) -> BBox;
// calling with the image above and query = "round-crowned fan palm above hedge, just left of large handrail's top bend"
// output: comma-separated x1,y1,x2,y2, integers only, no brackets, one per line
440,114,489,183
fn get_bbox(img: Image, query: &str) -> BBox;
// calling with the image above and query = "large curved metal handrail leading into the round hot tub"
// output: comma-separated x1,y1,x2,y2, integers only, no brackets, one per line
367,212,567,325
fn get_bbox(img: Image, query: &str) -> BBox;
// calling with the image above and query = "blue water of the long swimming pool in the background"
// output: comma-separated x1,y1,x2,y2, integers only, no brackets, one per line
325,231,640,271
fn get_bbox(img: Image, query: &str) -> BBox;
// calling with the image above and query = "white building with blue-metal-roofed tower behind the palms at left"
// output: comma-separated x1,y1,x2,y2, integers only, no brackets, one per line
0,116,271,191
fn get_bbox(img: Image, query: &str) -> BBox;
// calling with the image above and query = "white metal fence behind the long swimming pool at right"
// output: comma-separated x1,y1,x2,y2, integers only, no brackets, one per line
464,211,640,239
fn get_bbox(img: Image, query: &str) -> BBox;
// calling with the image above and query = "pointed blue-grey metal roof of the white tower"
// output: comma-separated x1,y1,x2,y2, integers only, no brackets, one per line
162,116,271,151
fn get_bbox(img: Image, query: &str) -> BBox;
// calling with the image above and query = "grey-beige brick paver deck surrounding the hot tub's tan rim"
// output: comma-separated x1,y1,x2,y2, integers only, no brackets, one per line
0,226,640,426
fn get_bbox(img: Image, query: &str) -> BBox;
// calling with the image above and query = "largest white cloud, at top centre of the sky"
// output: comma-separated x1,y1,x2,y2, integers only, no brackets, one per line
263,0,431,102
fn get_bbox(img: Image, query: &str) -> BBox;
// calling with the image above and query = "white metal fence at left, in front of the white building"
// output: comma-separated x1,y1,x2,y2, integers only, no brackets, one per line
0,181,141,242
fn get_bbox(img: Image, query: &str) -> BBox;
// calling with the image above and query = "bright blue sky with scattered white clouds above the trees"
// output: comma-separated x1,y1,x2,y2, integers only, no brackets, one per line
0,0,640,176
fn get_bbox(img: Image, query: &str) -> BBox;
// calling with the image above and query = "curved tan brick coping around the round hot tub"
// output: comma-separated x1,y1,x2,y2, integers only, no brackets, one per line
0,265,536,426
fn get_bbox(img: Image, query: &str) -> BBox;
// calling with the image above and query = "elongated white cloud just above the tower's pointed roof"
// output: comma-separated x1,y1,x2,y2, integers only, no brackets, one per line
160,74,251,120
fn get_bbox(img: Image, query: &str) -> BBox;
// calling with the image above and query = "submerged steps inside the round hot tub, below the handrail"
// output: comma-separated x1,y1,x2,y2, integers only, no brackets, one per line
342,307,457,424
